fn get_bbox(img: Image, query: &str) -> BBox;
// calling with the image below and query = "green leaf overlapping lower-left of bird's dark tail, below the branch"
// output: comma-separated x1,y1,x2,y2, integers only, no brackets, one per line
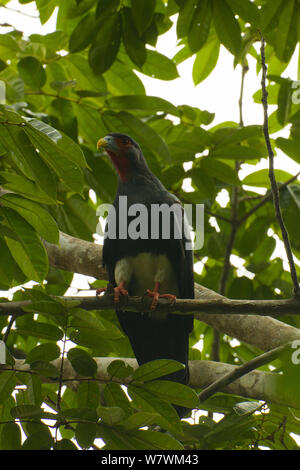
132,359,184,382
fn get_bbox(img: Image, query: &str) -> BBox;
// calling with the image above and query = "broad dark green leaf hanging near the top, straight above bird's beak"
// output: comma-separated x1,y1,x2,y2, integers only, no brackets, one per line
89,13,121,74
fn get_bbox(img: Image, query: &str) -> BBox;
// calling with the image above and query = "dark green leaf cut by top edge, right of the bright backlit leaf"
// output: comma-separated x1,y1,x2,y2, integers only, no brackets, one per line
213,0,241,55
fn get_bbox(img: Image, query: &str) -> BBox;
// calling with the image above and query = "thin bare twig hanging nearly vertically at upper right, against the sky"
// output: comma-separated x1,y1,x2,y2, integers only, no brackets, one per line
261,36,300,298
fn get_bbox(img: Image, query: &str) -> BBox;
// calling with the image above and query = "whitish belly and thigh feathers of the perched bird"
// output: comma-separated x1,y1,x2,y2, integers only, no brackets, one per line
115,253,178,296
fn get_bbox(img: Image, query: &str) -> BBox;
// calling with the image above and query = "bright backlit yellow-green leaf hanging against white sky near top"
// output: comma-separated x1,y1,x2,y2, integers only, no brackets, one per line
192,36,220,85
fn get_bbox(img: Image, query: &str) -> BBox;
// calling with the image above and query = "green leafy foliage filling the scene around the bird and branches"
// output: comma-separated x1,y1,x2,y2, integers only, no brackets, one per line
0,0,300,449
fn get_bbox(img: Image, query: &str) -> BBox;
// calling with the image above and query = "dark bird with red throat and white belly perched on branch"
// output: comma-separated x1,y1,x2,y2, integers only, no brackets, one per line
97,133,194,418
